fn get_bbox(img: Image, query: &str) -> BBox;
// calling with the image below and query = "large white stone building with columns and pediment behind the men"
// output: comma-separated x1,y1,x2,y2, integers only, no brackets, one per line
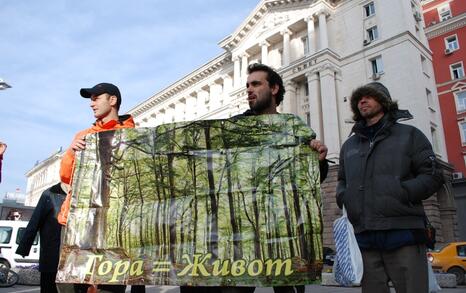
129,0,457,246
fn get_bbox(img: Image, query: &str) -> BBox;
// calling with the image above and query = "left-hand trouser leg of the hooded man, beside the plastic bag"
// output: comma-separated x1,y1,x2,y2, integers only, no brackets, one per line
361,249,390,293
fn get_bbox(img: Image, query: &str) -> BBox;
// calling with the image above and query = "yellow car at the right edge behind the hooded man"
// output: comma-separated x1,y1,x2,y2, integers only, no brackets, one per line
427,242,466,284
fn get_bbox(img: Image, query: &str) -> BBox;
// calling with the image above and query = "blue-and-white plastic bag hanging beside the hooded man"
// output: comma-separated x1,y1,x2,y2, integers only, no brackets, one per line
333,206,363,286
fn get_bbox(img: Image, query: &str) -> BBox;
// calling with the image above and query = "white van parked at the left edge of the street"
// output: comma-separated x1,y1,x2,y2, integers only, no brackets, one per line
0,220,40,268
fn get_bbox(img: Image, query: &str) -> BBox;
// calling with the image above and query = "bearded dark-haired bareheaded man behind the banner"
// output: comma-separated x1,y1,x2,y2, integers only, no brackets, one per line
180,63,328,293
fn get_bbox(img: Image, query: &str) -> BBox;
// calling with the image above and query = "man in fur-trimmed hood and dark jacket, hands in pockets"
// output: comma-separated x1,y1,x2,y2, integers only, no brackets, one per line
337,82,443,293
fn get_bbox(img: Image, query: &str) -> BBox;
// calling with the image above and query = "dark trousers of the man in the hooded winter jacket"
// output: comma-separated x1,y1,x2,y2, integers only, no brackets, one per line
361,244,429,293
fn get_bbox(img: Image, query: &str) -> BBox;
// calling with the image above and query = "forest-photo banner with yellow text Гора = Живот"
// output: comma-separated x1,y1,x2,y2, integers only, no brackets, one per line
57,114,322,287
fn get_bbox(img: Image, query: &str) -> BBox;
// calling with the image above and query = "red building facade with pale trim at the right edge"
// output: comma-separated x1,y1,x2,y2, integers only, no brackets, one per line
421,0,466,240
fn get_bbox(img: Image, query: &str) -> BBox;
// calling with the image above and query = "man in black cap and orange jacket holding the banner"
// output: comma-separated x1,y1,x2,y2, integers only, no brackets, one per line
58,83,144,292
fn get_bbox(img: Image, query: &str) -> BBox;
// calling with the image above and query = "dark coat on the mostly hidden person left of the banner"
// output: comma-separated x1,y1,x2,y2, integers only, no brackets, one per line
16,184,66,273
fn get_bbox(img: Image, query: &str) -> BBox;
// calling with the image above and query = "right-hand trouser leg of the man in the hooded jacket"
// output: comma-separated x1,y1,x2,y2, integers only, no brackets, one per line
380,245,429,293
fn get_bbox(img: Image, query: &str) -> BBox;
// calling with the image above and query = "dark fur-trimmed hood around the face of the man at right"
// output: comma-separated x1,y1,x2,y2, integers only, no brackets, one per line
350,81,398,121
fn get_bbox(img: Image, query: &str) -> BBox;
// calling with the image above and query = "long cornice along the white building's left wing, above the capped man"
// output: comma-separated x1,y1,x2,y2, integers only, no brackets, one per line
128,53,231,116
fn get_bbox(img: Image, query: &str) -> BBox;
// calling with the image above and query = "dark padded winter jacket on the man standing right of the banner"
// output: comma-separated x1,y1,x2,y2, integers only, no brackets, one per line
337,110,443,233
